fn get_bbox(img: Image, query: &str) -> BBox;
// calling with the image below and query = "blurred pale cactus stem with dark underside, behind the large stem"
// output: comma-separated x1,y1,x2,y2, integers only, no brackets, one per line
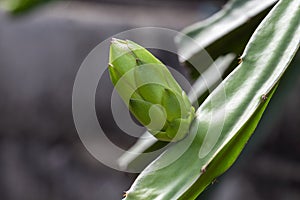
175,0,277,79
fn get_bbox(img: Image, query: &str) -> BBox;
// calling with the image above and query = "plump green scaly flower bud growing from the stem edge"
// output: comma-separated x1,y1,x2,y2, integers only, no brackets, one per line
108,39,195,142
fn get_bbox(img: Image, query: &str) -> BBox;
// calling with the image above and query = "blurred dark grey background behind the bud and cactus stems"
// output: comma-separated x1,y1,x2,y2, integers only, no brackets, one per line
0,0,300,200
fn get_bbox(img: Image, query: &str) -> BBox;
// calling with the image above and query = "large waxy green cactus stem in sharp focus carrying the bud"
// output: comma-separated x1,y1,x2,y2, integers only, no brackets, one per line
124,0,300,200
